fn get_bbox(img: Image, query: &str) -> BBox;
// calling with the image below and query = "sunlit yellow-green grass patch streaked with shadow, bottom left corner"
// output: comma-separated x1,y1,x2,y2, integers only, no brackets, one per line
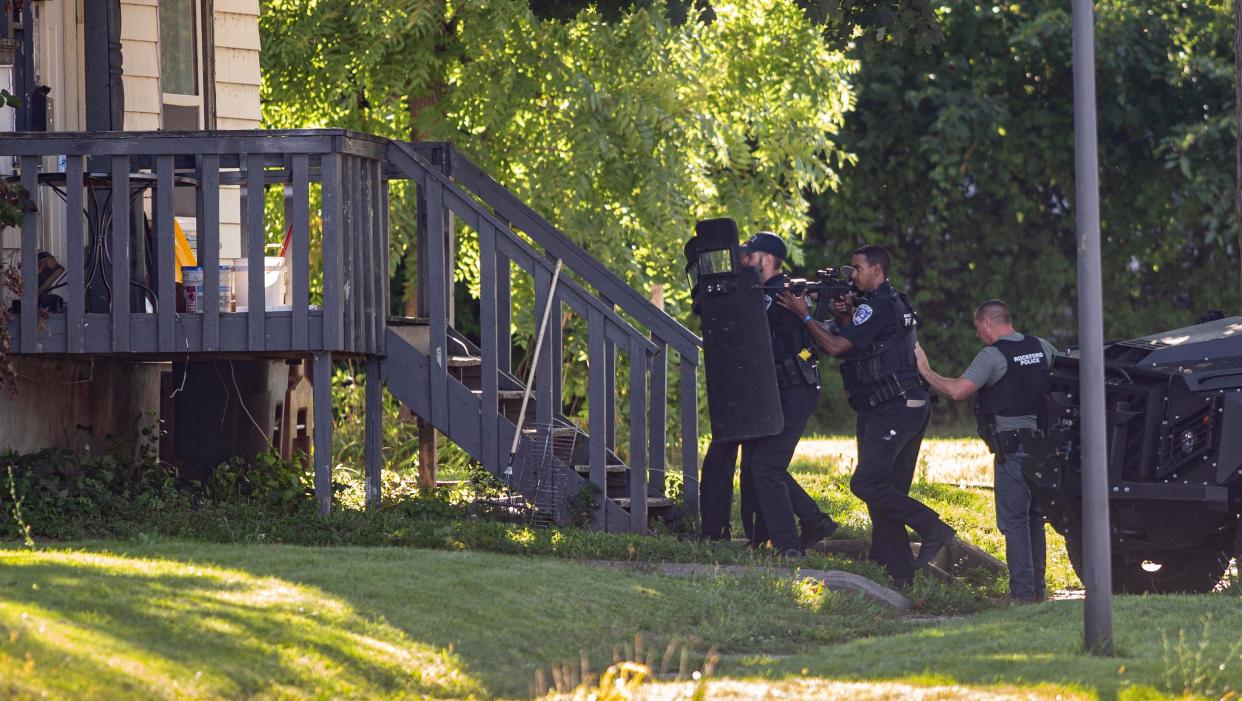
0,552,481,697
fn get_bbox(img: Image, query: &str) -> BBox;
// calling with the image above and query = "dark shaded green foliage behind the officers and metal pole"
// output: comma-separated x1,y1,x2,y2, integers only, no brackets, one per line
805,0,1238,422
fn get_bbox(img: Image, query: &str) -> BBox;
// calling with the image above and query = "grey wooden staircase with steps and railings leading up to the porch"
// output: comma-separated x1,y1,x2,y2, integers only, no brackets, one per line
380,142,702,532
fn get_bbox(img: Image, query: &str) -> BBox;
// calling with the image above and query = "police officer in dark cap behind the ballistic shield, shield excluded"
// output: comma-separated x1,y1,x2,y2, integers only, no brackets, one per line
699,231,837,557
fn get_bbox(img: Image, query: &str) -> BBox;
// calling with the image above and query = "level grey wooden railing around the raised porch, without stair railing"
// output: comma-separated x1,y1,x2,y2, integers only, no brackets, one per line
0,129,389,354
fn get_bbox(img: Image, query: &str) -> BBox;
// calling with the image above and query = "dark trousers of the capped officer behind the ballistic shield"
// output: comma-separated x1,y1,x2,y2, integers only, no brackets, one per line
699,385,822,548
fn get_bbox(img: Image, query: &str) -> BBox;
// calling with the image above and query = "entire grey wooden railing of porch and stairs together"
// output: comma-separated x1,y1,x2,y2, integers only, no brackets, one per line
0,129,700,531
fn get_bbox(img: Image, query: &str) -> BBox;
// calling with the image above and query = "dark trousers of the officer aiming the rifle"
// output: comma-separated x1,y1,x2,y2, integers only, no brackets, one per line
850,396,943,579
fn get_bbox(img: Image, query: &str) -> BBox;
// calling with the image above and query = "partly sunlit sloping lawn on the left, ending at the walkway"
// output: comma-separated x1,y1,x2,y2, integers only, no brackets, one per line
0,542,905,699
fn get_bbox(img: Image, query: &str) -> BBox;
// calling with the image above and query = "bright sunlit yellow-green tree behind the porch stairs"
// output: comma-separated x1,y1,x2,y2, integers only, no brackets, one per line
261,0,854,318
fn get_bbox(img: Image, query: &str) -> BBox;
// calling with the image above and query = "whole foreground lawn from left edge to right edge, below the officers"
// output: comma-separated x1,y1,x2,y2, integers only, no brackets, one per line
0,542,1242,699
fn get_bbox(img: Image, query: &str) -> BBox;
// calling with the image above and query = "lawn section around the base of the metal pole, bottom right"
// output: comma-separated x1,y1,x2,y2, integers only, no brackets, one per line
725,594,1242,700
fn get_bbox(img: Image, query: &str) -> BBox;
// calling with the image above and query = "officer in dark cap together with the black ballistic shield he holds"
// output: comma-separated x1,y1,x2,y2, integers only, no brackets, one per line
686,219,836,556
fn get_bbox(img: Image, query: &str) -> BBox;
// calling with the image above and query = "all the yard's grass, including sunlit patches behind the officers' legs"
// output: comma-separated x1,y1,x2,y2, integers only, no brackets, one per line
0,439,1242,700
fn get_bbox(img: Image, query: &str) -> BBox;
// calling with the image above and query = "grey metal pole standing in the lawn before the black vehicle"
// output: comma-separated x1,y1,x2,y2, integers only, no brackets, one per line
1073,0,1113,655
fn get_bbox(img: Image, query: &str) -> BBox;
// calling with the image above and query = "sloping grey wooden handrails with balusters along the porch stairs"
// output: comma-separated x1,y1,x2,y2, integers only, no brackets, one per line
389,142,700,531
